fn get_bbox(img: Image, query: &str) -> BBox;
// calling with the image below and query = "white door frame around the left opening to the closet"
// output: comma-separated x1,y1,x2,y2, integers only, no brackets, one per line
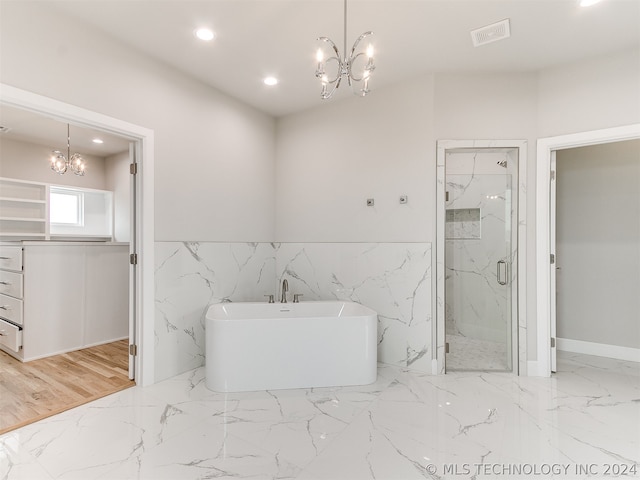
0,83,154,386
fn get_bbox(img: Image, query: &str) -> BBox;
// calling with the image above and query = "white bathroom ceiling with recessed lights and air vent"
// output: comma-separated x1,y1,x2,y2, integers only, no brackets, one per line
47,0,640,116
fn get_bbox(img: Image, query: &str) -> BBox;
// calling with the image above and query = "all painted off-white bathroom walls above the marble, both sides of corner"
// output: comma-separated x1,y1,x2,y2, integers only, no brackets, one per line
0,2,640,372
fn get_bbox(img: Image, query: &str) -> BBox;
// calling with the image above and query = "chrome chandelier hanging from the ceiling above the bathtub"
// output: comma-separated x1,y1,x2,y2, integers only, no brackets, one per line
316,0,376,99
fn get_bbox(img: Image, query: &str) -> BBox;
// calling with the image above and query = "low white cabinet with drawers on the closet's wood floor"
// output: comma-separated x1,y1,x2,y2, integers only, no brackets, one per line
0,242,129,361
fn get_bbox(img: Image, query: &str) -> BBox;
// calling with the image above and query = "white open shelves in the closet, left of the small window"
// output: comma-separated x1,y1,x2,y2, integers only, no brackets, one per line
0,178,49,240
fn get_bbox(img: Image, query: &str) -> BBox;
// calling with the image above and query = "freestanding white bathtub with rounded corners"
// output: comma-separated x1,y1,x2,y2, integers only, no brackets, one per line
206,301,378,392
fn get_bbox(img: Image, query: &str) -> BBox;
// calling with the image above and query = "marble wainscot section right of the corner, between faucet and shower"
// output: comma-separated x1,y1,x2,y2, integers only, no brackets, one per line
276,243,433,372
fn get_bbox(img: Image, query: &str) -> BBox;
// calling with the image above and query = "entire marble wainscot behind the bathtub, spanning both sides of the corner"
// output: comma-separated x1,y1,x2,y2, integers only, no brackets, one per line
155,242,432,381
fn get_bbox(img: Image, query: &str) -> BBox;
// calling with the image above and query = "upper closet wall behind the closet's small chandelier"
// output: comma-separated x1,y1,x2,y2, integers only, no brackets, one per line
0,138,106,190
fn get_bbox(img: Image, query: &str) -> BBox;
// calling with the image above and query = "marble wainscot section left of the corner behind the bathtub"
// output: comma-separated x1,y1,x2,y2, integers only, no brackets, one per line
155,242,275,381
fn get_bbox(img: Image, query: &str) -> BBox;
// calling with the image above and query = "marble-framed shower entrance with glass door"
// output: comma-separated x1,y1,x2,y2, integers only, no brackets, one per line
436,140,526,374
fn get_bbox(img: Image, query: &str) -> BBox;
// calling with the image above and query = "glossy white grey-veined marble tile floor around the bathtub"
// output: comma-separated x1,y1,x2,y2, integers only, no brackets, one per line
0,354,640,480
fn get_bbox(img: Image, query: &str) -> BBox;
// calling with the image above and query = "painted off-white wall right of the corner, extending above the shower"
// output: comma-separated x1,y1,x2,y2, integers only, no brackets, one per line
276,57,640,359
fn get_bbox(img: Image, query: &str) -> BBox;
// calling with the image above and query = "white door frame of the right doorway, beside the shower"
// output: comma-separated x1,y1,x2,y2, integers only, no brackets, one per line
529,123,640,377
